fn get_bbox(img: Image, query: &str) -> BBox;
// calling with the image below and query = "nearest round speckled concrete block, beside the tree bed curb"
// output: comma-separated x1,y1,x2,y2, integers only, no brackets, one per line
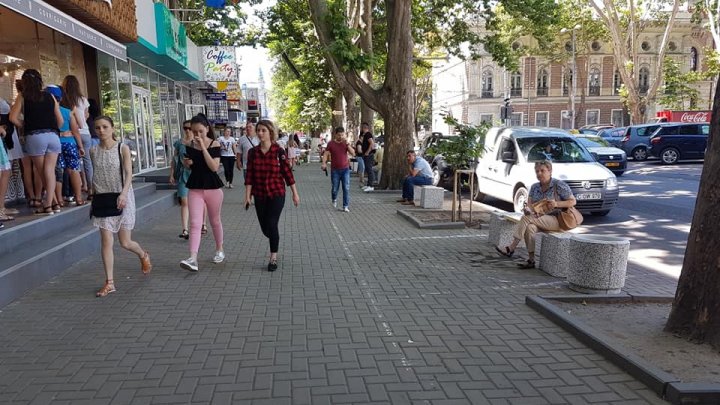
567,234,630,294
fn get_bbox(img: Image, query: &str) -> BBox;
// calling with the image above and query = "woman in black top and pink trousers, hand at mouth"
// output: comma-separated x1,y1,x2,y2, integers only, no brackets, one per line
180,114,225,271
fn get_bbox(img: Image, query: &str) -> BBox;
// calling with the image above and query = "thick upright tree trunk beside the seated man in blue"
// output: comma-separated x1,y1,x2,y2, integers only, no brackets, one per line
379,0,415,190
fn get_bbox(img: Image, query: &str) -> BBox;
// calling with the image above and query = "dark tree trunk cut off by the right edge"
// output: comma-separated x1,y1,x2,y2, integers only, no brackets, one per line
665,77,720,349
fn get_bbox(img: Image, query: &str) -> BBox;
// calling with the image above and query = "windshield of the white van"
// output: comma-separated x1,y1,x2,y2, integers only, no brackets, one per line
517,137,595,163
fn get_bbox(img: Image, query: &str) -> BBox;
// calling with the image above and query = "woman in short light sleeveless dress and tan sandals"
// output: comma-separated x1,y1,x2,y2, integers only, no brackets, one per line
90,116,152,297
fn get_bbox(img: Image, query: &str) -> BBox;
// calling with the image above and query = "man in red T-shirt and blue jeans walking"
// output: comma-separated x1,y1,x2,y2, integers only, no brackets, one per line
320,127,355,212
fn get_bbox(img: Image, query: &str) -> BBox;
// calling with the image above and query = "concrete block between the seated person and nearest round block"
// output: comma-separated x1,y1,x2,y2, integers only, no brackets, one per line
535,232,573,277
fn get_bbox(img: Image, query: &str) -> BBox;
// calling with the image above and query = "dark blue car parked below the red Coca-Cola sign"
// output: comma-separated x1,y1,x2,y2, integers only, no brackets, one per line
650,123,710,165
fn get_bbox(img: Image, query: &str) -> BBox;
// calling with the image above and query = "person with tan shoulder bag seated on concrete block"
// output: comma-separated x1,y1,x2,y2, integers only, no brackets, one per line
495,160,575,269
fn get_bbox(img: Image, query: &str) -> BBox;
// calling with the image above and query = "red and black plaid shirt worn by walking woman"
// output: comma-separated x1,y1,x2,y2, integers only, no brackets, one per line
245,143,295,198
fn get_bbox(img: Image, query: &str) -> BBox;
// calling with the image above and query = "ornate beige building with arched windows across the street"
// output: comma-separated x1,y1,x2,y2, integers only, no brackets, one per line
433,14,714,133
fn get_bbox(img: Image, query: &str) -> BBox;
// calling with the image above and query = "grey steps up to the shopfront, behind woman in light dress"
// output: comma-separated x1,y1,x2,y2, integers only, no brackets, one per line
0,182,175,307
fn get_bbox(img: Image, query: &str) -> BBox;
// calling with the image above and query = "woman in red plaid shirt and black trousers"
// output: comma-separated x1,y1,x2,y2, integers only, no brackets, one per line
245,120,300,271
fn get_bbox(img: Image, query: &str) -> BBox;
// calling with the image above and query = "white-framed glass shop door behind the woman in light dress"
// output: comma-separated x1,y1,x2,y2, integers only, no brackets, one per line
133,87,156,172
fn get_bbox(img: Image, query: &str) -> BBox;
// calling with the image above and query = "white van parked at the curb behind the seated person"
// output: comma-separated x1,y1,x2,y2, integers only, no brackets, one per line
475,127,619,215
